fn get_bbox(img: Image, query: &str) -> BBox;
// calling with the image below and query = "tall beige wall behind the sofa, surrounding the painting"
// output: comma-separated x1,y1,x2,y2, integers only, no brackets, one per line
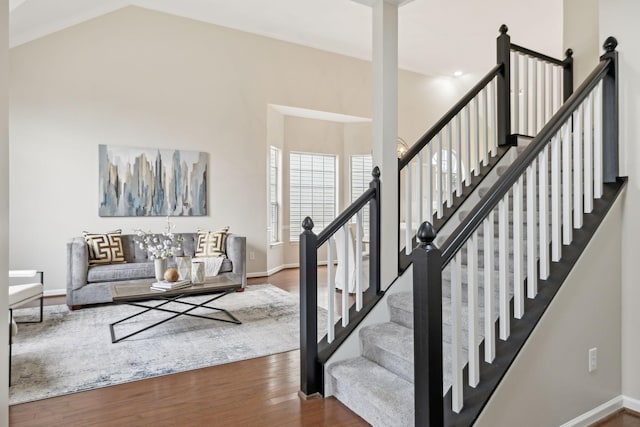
10,7,468,290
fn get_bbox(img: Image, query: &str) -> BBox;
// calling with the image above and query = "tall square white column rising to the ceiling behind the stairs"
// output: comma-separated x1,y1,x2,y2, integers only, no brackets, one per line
353,0,411,289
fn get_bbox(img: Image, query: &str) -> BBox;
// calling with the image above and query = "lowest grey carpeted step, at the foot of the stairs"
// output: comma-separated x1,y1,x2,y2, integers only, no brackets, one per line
328,357,414,427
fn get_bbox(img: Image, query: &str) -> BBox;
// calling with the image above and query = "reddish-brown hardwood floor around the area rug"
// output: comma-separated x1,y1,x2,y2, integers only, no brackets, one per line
9,269,368,427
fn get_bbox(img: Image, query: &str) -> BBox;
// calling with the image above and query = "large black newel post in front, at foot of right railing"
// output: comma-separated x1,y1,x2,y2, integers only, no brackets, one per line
412,222,444,427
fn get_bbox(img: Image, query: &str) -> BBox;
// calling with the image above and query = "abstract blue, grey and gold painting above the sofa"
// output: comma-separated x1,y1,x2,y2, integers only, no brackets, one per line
98,145,207,216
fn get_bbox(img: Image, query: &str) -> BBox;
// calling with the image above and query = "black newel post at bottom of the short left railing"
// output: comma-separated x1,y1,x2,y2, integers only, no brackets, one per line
300,217,323,397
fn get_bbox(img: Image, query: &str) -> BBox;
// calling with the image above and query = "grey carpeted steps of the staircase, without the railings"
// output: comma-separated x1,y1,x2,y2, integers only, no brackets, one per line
327,153,538,426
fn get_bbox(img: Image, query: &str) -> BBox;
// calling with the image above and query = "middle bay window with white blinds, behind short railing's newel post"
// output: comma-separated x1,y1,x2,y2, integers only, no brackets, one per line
289,153,337,242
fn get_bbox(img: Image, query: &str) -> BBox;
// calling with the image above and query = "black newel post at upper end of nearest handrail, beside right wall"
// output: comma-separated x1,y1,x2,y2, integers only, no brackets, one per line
600,37,618,182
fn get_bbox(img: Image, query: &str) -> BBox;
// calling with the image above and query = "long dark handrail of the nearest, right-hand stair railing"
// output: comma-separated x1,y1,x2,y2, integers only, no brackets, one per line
442,58,612,268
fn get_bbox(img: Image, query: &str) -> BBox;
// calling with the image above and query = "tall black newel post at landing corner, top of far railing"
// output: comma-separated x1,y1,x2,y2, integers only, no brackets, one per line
496,24,511,145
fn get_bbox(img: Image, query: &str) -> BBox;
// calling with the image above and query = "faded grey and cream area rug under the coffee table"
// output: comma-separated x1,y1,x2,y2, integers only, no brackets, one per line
9,284,326,405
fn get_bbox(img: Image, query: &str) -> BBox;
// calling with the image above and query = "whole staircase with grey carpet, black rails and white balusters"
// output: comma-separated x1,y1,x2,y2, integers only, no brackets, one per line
300,26,626,426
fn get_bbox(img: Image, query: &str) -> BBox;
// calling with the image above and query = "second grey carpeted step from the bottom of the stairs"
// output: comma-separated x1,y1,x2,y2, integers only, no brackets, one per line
360,322,413,382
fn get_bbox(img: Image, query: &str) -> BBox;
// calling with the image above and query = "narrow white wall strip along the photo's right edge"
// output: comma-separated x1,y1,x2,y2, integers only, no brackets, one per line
599,0,640,399
